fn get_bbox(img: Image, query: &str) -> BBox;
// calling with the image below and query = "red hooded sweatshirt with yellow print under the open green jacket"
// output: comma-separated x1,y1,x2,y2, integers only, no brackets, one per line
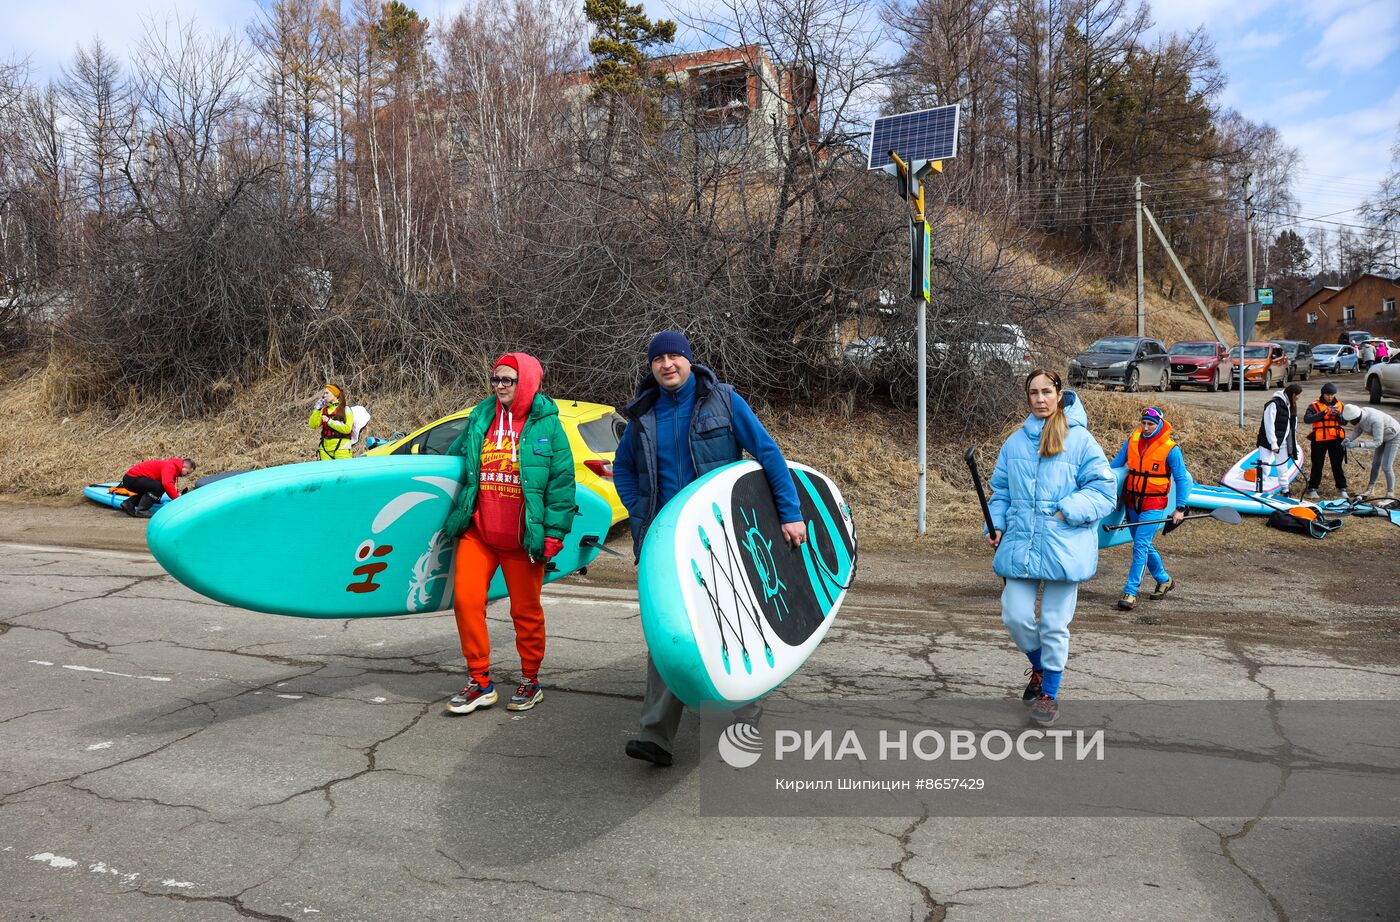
472,353,545,557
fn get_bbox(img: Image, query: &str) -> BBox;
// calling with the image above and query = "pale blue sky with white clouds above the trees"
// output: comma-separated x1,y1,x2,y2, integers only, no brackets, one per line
0,0,1400,242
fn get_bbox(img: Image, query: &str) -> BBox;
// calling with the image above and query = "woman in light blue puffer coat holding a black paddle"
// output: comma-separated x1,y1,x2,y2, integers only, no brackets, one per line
987,368,1119,725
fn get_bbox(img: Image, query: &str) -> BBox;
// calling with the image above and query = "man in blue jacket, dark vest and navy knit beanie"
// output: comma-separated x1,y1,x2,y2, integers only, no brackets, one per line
613,330,806,767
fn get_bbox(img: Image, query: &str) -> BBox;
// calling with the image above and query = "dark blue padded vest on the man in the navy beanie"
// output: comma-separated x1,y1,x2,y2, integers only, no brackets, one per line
623,365,742,557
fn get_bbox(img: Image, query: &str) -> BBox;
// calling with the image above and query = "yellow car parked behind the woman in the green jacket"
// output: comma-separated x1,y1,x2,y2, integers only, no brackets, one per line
365,400,627,525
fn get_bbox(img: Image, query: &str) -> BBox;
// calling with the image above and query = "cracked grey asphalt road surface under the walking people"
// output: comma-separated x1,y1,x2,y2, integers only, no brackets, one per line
0,544,1400,922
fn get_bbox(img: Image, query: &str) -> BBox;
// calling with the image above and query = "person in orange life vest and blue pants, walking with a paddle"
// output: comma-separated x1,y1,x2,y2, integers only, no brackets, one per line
1112,407,1191,611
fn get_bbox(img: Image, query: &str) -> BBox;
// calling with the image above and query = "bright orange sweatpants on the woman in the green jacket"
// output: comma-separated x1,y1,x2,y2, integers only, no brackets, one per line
452,529,545,686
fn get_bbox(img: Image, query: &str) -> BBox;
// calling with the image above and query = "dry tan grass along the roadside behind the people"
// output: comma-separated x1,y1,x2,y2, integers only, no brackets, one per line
0,374,1392,553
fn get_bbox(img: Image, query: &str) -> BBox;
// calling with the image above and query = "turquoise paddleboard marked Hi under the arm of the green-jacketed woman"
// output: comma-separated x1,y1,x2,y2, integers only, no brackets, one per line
146,456,612,618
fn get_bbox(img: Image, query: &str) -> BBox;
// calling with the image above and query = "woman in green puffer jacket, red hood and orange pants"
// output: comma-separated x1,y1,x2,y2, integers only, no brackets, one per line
442,353,578,714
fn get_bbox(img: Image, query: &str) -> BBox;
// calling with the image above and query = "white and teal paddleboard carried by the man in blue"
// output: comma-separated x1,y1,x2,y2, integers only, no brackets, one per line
638,460,857,711
